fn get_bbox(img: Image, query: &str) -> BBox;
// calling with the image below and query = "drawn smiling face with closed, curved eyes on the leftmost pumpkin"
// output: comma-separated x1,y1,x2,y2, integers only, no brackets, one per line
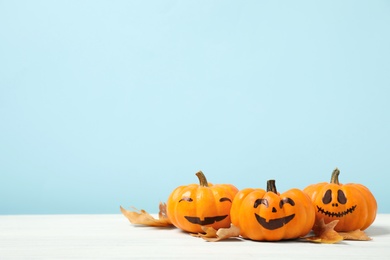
179,196,232,226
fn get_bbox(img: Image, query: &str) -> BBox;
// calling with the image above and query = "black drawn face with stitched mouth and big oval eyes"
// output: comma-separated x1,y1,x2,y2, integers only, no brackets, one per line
316,187,357,218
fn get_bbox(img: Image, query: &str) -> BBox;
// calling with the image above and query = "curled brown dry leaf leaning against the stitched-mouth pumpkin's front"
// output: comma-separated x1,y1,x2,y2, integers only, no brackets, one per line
305,219,343,244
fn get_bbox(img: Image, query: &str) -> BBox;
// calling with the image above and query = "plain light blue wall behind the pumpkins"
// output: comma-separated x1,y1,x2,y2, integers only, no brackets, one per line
0,0,390,214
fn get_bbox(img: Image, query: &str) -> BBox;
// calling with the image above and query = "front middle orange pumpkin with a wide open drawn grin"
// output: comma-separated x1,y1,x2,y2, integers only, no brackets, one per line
230,180,315,241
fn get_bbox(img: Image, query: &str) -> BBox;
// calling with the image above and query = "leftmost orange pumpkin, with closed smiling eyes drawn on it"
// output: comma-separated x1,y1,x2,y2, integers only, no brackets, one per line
167,171,238,233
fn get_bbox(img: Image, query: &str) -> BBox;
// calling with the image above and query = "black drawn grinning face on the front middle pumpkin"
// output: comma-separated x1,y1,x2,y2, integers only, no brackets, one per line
253,197,295,230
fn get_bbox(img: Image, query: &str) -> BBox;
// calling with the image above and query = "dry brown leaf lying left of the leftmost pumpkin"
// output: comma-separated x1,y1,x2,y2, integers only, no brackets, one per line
120,202,172,227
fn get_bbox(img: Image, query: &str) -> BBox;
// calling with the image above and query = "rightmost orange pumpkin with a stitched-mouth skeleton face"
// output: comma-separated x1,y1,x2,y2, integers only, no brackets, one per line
304,168,377,232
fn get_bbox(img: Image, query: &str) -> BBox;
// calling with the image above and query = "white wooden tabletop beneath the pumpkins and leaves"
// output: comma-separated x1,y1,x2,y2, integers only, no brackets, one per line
0,214,390,260
